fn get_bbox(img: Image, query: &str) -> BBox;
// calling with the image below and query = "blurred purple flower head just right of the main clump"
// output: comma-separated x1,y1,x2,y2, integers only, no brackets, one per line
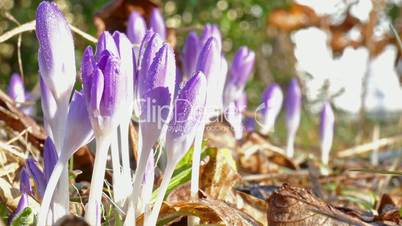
230,46,255,87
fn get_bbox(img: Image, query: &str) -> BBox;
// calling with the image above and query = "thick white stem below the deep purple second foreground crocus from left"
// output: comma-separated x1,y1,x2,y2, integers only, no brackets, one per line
85,134,111,226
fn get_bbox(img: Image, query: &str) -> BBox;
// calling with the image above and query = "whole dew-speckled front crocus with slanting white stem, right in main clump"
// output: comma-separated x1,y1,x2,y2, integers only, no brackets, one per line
145,72,207,226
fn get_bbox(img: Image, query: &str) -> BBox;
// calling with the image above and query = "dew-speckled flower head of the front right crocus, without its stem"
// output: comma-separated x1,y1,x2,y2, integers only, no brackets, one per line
168,71,207,137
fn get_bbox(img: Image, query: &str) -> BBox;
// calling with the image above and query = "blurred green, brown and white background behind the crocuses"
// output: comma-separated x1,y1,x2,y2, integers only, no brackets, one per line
0,0,402,158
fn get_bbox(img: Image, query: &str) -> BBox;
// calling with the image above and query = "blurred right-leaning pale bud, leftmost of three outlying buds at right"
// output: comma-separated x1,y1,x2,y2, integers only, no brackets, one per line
260,83,283,134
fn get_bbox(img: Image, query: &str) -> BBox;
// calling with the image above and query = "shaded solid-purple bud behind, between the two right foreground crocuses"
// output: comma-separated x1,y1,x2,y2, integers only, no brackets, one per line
182,32,200,78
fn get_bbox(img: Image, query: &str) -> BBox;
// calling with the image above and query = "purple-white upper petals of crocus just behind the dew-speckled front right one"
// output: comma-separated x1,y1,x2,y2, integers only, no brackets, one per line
196,37,222,81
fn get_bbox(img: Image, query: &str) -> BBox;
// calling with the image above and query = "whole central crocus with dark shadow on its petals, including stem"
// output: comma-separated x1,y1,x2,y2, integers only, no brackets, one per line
126,33,176,224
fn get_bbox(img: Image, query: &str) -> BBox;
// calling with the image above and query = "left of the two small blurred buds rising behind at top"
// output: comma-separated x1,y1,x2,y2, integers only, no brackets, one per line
127,11,147,45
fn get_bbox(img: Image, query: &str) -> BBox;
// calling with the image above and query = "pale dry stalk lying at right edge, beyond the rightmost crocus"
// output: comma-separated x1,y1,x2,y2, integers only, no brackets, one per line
337,135,402,158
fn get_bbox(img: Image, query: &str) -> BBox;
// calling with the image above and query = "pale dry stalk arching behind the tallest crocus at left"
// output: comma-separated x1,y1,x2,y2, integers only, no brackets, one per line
0,20,97,43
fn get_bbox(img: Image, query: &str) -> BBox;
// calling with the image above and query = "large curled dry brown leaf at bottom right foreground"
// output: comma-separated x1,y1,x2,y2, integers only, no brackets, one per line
268,184,369,226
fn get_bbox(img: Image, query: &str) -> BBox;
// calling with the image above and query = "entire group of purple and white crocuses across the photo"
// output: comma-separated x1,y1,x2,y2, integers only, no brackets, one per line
9,1,340,226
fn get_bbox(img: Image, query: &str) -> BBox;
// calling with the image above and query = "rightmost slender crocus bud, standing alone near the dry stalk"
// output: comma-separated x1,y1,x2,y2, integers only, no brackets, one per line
320,102,335,165
